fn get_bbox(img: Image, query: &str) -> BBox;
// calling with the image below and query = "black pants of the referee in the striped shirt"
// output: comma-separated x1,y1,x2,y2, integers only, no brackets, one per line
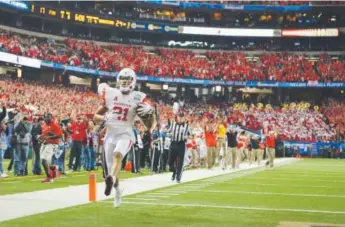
169,141,186,181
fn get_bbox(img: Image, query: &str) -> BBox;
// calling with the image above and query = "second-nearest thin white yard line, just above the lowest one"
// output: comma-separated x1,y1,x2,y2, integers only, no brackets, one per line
180,189,345,198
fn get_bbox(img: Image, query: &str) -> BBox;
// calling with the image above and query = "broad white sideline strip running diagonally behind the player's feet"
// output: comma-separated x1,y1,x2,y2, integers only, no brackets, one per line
0,158,296,223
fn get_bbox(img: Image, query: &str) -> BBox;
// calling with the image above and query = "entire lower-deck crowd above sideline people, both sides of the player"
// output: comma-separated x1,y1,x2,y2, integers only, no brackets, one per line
0,78,338,144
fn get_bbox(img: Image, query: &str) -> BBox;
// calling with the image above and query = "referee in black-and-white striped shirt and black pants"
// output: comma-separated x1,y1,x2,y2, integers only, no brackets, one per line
168,112,189,183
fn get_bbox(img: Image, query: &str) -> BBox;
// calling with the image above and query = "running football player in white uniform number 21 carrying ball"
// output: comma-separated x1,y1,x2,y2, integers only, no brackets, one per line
94,68,155,207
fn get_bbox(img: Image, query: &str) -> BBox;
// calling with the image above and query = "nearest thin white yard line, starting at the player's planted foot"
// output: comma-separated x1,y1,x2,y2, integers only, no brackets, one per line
117,201,345,214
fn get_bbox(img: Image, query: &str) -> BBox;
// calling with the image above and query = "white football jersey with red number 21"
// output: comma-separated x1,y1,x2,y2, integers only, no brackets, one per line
98,84,146,141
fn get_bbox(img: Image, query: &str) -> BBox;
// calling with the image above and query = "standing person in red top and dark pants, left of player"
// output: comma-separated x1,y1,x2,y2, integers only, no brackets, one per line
68,111,88,171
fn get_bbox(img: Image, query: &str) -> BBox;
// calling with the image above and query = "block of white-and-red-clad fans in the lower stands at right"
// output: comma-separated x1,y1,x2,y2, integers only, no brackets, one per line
231,102,336,142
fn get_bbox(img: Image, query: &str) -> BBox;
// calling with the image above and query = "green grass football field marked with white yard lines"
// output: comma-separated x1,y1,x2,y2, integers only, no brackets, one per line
0,159,345,227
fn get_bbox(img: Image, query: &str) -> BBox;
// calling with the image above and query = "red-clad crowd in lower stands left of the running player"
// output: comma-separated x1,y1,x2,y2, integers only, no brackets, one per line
0,77,99,120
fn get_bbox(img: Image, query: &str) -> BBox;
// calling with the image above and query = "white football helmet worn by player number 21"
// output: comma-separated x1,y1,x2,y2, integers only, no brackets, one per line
116,68,137,94
